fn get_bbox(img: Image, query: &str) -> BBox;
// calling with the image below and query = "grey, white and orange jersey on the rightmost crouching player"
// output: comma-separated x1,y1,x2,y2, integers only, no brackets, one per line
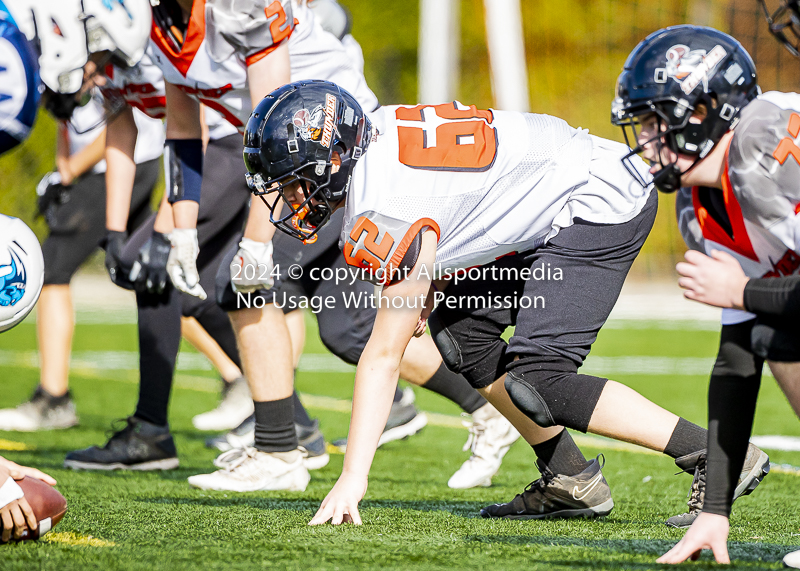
680,92,800,325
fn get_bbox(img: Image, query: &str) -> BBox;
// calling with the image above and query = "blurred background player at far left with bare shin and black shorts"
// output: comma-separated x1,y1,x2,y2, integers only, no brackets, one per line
0,92,164,431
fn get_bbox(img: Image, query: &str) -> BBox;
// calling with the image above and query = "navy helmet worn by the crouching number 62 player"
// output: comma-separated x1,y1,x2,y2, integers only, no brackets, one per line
244,80,372,242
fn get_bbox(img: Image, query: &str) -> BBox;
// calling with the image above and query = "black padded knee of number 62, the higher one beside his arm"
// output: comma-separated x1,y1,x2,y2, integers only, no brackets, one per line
428,308,511,389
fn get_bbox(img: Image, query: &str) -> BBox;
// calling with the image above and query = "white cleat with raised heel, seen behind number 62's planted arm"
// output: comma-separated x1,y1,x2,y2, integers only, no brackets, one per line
447,403,519,490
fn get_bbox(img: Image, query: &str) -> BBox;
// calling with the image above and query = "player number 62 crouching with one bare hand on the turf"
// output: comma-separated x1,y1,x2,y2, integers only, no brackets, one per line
245,82,760,524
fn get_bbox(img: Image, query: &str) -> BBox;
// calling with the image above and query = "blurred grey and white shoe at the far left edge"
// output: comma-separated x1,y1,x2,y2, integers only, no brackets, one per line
0,387,78,432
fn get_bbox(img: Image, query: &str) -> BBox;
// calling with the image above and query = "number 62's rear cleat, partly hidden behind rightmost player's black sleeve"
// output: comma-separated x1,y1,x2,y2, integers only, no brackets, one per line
666,444,769,529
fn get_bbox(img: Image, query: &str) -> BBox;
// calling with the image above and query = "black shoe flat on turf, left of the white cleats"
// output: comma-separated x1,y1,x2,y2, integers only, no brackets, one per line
64,416,178,470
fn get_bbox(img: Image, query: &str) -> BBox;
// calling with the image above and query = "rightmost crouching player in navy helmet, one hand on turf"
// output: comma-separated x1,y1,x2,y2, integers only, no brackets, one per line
612,21,800,566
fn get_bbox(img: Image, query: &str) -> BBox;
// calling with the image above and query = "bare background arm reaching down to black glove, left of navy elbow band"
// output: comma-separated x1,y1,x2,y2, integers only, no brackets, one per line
105,106,139,232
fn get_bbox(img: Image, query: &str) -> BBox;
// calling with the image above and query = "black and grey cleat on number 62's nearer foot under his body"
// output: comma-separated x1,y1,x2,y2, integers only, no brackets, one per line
481,455,614,519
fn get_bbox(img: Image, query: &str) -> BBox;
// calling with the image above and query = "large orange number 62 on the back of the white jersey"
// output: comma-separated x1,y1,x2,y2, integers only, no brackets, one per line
396,102,497,172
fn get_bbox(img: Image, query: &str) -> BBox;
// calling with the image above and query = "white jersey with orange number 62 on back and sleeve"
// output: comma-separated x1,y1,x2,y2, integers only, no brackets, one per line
340,102,649,282
